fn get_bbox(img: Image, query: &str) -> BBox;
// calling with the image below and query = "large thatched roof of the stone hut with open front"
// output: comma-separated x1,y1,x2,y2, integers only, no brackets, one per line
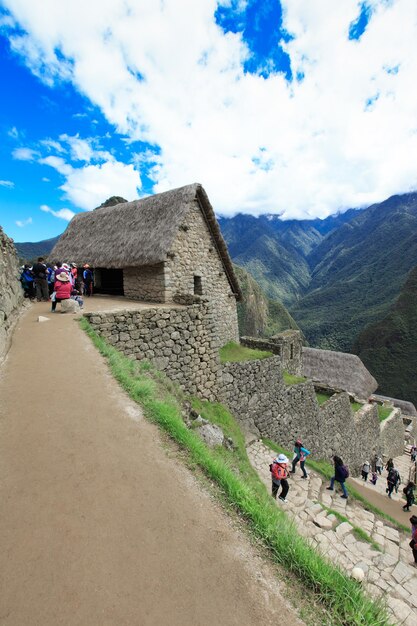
49,183,241,299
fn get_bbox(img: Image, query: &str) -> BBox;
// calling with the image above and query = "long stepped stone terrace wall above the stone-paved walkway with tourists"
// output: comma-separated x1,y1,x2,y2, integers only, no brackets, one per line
220,356,394,473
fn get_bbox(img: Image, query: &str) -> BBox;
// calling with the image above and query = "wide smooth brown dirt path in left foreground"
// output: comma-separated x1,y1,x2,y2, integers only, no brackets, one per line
0,303,300,626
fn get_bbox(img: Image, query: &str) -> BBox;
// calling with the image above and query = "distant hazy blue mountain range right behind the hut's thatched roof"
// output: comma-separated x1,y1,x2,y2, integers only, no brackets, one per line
218,210,357,306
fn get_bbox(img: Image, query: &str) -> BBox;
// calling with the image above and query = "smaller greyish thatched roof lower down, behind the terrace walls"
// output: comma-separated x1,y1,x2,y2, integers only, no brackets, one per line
303,348,378,399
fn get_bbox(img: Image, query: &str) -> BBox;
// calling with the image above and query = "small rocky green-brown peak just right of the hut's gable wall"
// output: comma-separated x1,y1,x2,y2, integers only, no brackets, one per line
234,265,299,337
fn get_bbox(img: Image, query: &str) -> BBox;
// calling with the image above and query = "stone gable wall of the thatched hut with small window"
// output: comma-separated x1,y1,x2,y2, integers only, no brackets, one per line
166,201,239,345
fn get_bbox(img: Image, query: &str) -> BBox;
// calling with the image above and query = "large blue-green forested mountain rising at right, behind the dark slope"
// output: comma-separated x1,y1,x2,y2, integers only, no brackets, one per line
290,193,417,352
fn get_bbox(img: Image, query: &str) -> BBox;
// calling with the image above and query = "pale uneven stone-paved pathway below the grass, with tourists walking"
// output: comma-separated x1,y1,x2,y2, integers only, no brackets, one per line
247,441,417,626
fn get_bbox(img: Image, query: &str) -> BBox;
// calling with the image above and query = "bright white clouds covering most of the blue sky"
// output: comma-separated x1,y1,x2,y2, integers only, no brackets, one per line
5,0,417,217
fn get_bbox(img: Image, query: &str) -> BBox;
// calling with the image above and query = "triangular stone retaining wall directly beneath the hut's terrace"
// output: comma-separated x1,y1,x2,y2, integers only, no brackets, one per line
85,298,220,400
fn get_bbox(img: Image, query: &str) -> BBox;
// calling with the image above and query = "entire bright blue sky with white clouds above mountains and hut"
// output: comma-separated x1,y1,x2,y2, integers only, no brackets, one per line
0,0,417,241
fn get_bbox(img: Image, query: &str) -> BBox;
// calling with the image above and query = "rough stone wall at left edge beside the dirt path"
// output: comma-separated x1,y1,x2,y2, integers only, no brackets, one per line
0,227,23,361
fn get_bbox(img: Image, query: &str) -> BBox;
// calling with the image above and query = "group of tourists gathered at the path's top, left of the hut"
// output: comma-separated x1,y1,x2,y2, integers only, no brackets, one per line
19,257,94,312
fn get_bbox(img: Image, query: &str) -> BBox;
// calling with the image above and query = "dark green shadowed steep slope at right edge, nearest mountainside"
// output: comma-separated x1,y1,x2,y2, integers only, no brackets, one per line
353,266,417,404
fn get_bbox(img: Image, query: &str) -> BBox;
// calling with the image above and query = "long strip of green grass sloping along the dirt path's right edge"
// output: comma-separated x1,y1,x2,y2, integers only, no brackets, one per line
80,318,391,626
